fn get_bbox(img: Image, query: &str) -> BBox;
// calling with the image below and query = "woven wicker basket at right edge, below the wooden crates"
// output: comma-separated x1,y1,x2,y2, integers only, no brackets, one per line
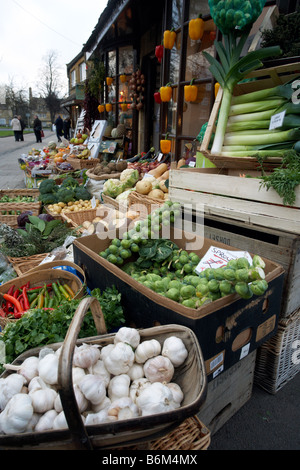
254,308,300,394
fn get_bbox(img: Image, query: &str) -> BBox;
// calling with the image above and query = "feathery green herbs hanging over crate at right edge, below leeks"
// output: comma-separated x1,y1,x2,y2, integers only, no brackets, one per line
256,150,300,206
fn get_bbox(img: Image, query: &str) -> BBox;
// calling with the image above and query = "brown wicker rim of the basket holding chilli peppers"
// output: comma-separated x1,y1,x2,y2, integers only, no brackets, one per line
0,260,85,329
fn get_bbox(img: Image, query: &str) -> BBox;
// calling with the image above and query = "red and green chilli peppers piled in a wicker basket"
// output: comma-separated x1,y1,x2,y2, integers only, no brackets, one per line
0,280,75,318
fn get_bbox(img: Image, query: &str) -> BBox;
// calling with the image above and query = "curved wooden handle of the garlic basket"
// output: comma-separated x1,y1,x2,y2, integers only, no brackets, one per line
58,297,107,450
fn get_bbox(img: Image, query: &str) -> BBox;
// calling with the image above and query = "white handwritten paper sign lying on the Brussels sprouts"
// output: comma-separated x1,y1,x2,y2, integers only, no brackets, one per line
195,246,252,274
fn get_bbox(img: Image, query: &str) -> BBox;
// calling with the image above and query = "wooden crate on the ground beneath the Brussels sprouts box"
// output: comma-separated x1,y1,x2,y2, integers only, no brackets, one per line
197,350,257,435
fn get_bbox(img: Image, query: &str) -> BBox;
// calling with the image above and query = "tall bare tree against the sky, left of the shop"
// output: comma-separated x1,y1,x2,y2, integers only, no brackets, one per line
37,51,63,123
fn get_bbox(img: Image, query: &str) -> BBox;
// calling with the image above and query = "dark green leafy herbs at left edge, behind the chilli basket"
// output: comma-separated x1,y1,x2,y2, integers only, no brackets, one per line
0,215,77,257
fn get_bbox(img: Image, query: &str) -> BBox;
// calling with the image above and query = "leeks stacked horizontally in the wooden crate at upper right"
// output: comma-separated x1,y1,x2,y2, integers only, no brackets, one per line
220,80,300,157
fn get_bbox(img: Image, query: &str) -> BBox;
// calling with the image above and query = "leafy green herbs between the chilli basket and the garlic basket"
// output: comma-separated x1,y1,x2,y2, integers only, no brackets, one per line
1,286,125,370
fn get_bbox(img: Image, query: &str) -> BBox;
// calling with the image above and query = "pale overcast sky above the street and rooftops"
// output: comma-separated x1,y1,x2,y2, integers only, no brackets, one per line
0,0,107,95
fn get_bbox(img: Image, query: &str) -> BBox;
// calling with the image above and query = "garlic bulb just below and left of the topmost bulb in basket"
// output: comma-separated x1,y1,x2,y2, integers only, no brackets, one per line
103,343,134,375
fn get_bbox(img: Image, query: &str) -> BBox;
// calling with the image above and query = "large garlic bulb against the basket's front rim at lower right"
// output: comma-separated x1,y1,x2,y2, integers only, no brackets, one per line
136,382,177,416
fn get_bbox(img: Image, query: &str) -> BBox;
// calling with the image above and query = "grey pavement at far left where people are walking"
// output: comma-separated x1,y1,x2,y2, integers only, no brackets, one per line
0,129,57,189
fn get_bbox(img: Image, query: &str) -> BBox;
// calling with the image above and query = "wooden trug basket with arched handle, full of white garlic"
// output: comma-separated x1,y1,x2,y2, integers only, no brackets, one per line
0,297,207,450
